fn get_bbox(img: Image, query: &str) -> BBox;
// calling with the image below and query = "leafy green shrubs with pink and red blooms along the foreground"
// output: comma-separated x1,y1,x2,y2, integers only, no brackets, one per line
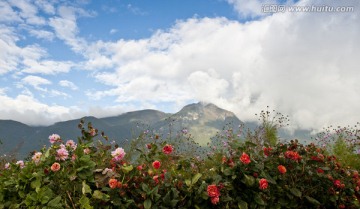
0,118,360,209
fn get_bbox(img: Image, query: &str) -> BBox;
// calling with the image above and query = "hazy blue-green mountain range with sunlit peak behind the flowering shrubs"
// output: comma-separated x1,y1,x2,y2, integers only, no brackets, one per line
0,102,309,157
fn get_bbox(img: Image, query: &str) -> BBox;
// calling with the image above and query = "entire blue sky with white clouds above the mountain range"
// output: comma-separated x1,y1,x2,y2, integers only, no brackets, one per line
0,0,360,129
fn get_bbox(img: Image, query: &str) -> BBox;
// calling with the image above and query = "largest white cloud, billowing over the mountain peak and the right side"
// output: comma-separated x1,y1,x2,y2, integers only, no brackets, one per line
89,1,360,131
